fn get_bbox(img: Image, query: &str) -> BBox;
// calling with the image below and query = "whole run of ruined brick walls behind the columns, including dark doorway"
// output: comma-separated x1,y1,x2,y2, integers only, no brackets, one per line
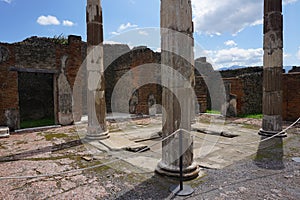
0,36,300,129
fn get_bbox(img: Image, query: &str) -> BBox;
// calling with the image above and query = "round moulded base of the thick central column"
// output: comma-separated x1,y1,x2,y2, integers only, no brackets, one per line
155,161,200,180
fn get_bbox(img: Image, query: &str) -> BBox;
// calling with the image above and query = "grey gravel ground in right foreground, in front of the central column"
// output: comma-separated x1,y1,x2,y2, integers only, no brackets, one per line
109,160,300,200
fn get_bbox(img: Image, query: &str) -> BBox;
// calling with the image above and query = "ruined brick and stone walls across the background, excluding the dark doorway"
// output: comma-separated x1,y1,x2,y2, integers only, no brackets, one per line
0,36,300,129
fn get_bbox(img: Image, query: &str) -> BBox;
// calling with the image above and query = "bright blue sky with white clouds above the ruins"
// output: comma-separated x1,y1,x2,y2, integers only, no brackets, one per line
0,0,300,68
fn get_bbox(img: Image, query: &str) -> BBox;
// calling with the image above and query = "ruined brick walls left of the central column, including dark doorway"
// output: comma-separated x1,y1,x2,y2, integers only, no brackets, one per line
0,35,161,130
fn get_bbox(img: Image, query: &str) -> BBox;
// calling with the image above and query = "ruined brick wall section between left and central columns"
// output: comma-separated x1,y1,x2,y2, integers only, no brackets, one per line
104,45,161,114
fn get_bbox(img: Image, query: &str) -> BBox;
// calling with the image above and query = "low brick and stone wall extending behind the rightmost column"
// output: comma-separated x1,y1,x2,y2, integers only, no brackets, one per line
221,68,300,121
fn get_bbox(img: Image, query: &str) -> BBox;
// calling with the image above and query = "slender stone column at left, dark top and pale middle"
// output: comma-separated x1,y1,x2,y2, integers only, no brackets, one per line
86,0,109,140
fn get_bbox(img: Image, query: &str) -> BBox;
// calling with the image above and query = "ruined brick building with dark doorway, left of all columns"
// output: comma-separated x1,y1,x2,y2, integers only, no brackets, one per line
0,36,84,129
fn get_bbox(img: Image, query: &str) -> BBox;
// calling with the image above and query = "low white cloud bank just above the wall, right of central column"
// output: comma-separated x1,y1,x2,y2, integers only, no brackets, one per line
205,47,263,69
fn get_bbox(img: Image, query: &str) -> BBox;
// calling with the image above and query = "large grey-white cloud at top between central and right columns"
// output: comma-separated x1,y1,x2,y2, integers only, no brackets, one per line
192,0,263,35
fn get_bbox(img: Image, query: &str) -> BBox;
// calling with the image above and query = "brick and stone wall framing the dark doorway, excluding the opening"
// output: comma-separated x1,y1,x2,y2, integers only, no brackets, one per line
0,36,83,129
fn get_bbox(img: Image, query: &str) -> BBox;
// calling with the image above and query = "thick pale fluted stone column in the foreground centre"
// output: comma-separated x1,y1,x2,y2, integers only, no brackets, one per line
156,0,199,179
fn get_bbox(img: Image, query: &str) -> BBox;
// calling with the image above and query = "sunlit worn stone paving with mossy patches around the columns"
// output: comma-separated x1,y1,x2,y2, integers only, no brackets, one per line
0,116,300,199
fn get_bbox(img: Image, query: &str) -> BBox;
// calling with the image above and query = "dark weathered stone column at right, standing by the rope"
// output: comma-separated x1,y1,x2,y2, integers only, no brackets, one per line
259,0,285,136
